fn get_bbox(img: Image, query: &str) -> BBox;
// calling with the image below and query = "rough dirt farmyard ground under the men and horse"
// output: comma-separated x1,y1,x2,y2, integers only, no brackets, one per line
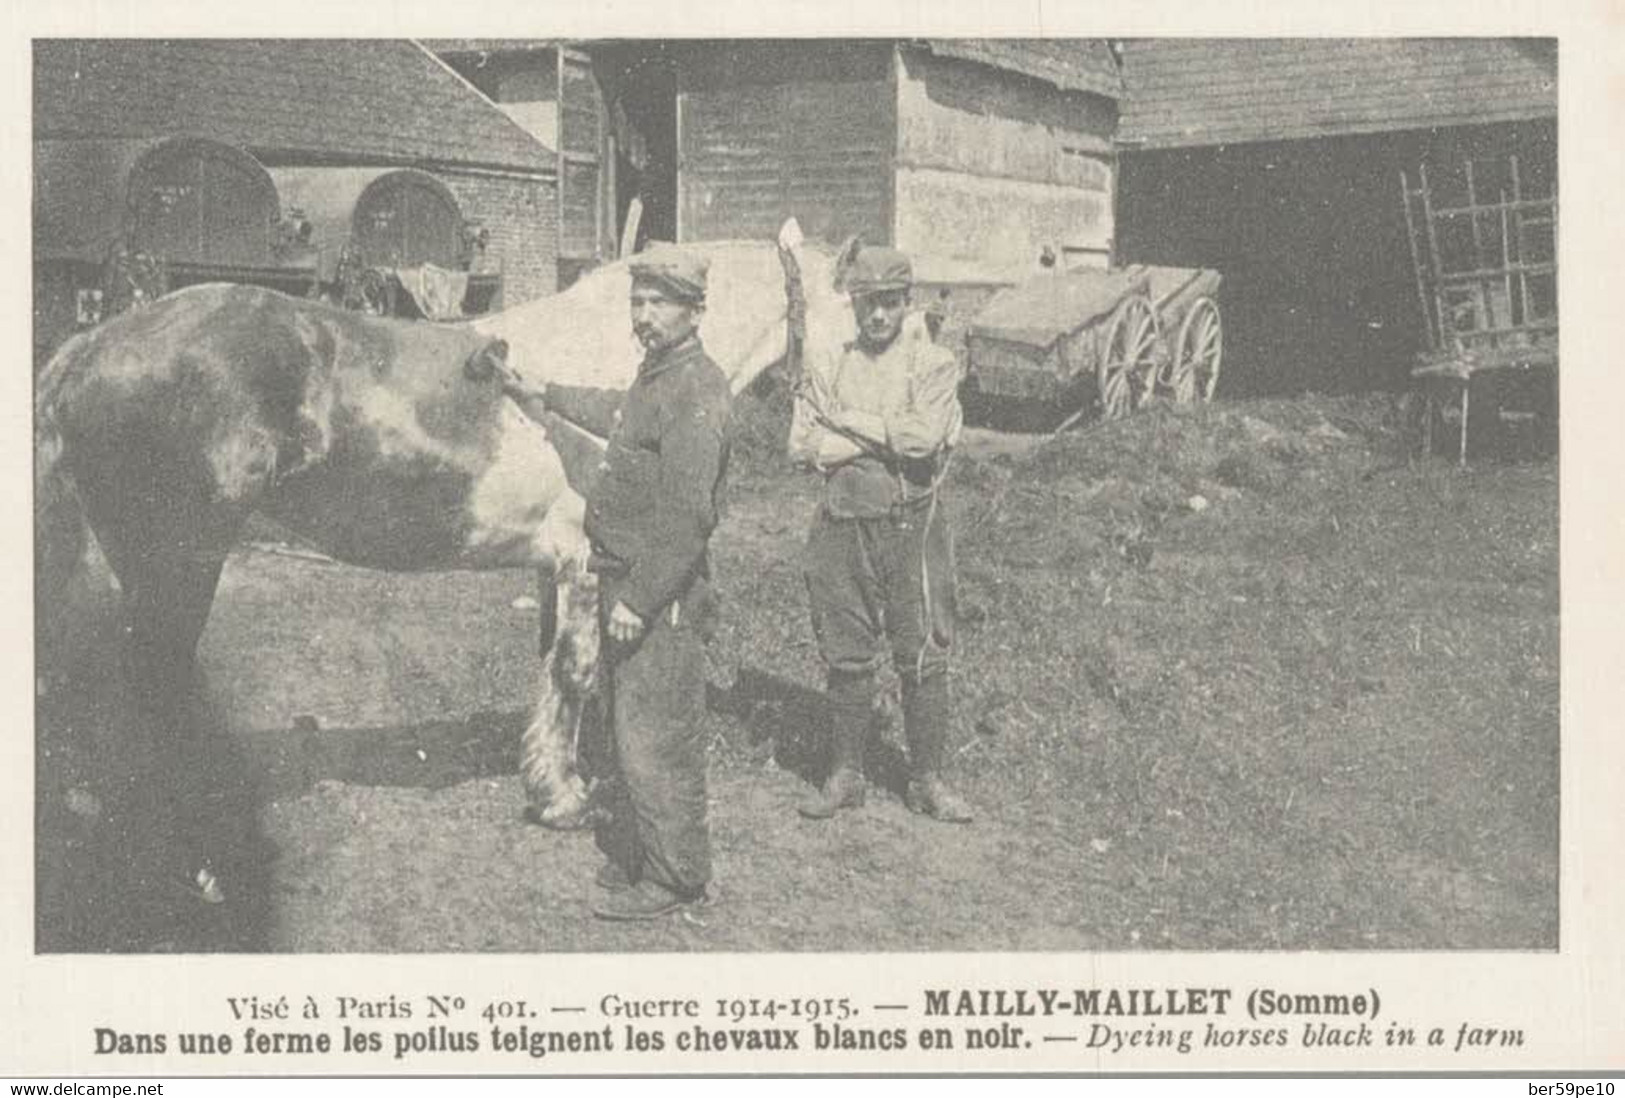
37,395,1558,952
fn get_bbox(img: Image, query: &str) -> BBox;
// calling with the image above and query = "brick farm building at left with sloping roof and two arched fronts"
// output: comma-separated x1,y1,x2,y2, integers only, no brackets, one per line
34,39,557,361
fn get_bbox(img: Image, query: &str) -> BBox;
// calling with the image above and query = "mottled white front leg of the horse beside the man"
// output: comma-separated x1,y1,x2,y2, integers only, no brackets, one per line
520,497,598,830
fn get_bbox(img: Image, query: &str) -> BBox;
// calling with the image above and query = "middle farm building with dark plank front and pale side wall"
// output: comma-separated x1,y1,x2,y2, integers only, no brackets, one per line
429,39,1118,292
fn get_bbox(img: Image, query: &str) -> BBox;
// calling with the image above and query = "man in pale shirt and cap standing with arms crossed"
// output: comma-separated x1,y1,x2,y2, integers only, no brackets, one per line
790,247,972,824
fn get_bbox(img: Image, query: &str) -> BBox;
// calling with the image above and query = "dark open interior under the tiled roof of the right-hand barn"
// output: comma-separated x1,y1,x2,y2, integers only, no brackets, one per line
1116,122,1557,396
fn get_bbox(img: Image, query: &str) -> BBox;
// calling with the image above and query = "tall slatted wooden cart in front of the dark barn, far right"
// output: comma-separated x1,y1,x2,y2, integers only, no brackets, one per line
1399,156,1558,463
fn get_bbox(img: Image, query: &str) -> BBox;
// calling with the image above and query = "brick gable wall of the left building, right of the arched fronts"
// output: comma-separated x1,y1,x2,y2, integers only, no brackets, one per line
439,171,559,309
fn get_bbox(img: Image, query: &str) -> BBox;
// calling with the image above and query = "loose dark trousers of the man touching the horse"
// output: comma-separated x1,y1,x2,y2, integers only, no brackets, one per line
600,581,710,897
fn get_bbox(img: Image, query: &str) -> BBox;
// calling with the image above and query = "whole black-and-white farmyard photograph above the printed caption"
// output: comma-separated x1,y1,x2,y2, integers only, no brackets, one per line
16,2,1625,1070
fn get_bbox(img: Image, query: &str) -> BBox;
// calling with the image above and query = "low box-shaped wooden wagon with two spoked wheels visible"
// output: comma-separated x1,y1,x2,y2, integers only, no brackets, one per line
967,265,1224,417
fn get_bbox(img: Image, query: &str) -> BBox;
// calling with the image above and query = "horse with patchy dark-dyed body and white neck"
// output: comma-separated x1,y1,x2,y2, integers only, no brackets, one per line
34,221,856,877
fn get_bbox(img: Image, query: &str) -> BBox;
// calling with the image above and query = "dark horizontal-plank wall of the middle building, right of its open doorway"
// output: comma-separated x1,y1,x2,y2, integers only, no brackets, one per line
679,41,894,244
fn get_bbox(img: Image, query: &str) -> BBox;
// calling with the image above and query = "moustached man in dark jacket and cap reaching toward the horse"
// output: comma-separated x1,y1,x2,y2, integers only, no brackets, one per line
528,245,731,919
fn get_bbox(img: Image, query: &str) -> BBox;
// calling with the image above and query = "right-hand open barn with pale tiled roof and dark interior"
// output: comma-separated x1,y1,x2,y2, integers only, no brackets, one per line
1116,39,1557,393
